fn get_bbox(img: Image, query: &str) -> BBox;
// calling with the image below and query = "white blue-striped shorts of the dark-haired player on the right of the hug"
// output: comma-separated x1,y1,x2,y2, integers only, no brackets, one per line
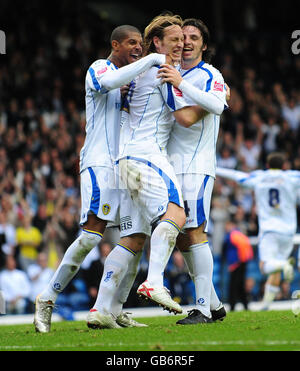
177,173,214,232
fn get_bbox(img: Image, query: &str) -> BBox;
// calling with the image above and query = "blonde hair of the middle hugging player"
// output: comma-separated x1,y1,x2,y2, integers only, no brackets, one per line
144,12,183,55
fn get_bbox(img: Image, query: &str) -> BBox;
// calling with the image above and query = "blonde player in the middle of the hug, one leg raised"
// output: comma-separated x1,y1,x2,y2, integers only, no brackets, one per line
90,14,204,322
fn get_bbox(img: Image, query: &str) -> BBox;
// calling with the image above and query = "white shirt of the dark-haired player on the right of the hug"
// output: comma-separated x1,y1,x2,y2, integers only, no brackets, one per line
168,61,227,177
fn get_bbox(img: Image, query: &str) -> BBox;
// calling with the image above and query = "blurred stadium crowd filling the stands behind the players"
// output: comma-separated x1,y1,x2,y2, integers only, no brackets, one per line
0,2,300,319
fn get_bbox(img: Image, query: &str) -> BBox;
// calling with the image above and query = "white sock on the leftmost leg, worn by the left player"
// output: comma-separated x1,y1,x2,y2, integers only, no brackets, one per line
40,229,102,303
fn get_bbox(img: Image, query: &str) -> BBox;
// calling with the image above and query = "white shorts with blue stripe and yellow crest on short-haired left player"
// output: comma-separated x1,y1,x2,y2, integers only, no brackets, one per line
80,166,120,225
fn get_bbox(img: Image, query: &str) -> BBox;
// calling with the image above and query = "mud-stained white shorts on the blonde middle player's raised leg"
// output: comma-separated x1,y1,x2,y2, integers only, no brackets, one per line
118,156,184,224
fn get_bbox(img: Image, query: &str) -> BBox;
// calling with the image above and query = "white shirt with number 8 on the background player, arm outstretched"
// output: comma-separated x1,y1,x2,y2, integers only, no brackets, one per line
217,167,300,235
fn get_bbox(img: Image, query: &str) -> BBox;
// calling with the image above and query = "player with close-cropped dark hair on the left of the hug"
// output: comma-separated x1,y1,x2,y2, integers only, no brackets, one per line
34,25,166,332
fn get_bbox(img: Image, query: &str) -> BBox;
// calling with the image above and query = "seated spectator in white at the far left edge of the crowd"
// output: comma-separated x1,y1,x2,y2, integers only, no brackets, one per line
0,255,30,314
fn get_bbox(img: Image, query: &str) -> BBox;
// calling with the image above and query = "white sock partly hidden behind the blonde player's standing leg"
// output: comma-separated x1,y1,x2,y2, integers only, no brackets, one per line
111,251,142,317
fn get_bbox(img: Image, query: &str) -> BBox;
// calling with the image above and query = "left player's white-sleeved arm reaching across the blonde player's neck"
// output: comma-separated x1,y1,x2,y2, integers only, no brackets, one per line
100,53,166,90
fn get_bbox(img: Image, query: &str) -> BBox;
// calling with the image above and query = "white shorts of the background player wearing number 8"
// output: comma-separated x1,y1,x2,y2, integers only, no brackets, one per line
258,232,293,262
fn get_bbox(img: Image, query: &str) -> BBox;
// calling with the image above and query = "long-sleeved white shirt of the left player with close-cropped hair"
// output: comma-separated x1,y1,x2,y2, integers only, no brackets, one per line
80,53,166,171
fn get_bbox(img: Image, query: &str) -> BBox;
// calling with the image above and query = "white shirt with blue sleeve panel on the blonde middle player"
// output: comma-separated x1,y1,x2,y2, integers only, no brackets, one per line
120,66,188,160
